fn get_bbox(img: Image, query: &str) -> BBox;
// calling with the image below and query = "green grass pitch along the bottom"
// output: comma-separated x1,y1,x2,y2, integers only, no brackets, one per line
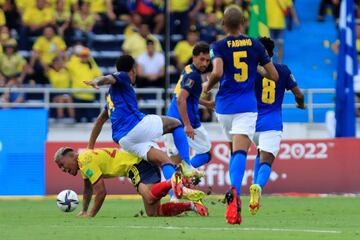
0,196,360,240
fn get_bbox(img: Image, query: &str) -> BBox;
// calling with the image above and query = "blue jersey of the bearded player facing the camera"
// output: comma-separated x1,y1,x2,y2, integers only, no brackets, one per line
167,64,202,128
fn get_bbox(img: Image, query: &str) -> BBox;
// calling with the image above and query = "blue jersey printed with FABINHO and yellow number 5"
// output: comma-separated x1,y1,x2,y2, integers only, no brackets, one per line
210,35,270,114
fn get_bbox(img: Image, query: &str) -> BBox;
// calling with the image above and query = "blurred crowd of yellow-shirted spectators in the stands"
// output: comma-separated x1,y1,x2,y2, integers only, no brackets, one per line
0,0,299,121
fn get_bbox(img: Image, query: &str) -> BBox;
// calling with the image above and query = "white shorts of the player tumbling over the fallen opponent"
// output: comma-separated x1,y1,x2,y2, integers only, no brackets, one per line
119,115,163,160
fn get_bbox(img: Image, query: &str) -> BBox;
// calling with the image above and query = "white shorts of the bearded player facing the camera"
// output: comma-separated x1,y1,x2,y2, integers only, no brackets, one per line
164,126,211,157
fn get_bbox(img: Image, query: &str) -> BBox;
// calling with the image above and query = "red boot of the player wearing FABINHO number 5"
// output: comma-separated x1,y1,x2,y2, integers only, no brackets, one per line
225,187,241,224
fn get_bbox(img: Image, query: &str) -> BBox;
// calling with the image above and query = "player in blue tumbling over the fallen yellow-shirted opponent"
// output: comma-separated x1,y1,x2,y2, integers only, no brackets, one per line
85,55,189,195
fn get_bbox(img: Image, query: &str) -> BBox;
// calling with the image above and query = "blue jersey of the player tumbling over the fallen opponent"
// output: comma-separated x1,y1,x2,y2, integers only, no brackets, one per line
105,72,145,142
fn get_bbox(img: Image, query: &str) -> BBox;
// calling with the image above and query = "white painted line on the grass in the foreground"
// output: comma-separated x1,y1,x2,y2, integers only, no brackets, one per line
125,226,342,234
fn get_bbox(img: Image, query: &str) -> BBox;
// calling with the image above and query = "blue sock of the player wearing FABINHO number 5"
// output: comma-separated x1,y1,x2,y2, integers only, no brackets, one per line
230,150,247,196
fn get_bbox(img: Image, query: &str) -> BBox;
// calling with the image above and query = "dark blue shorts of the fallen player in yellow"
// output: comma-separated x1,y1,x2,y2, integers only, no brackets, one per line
128,160,161,187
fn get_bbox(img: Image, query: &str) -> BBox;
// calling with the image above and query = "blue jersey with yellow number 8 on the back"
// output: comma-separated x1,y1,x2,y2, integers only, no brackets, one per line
255,64,297,132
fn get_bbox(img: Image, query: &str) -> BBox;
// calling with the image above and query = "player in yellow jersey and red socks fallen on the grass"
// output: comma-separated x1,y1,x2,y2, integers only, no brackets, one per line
54,147,208,217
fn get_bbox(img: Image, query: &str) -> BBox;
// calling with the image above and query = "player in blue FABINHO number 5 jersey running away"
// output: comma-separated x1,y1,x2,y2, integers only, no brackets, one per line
204,7,279,224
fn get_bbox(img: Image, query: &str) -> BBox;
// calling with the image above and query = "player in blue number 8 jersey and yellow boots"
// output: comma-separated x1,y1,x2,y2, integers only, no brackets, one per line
249,37,306,215
